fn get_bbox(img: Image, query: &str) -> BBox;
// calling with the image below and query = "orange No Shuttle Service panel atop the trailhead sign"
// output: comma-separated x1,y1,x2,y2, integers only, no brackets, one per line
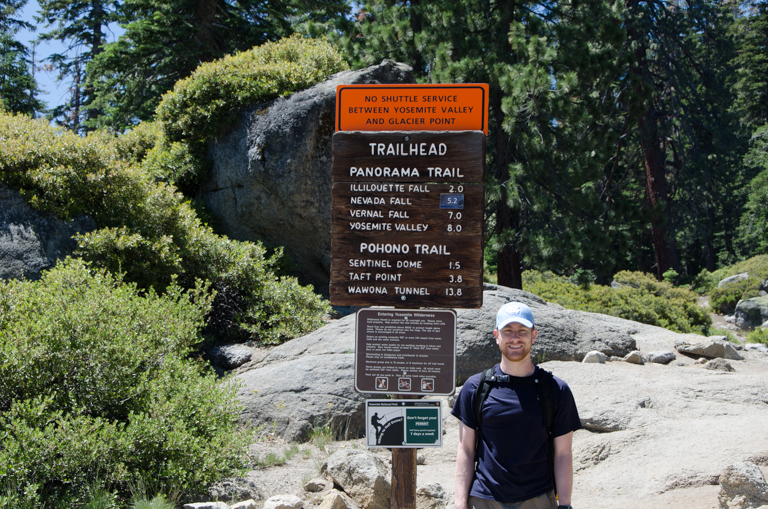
336,83,488,135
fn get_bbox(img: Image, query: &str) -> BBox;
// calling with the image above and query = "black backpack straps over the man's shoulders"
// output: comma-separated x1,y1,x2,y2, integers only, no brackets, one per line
473,367,557,494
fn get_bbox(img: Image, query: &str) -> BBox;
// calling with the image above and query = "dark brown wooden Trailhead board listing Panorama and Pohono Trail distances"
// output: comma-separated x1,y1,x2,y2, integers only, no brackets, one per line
330,131,485,308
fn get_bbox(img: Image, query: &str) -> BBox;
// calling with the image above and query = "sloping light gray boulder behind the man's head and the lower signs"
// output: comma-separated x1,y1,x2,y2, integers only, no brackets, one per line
233,285,637,440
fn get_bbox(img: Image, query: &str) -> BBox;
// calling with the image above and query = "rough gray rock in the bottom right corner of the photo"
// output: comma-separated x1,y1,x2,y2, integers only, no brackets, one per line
718,462,768,509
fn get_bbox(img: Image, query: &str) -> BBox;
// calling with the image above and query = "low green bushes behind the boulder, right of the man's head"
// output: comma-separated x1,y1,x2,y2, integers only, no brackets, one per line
523,270,712,333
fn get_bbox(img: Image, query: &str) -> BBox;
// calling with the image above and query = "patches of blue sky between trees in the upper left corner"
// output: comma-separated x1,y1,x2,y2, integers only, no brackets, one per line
17,0,123,108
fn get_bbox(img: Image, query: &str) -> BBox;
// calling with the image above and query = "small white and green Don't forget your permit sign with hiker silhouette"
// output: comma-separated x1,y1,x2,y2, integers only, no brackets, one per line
365,399,443,448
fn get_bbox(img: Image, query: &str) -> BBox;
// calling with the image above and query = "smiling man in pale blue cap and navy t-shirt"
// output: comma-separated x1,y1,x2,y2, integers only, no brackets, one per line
452,302,581,509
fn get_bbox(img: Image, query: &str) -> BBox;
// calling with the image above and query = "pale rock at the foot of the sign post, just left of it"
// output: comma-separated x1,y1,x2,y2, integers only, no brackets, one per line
321,449,391,509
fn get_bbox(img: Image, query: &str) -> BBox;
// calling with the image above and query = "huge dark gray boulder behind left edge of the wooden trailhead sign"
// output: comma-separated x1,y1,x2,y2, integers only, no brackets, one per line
200,61,414,294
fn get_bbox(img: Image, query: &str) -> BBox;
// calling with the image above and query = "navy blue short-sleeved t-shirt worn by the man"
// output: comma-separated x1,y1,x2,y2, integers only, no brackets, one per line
451,364,581,504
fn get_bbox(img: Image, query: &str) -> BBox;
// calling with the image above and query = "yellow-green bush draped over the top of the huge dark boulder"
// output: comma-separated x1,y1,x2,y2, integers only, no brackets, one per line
157,35,348,141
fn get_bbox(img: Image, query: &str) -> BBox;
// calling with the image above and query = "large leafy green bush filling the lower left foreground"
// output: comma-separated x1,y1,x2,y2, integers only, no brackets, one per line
0,259,251,508
